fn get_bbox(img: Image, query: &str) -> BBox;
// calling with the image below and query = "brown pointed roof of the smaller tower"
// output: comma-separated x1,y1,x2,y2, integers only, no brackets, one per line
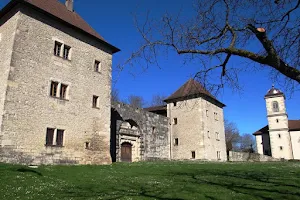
165,79,225,107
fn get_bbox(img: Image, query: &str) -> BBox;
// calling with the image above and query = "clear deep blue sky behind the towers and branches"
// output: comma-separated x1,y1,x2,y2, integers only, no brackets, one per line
0,0,300,133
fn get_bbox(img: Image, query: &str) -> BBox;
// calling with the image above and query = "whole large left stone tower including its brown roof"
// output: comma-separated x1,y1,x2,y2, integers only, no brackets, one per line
0,0,119,164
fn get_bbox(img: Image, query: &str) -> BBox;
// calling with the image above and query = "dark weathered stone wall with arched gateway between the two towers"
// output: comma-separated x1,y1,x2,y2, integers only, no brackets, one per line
111,102,170,161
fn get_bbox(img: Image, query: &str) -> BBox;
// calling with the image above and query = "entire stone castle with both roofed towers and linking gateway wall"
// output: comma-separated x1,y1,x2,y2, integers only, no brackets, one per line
0,0,226,164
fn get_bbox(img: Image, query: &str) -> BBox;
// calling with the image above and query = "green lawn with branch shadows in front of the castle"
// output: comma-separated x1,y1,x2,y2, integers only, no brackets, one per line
0,162,300,200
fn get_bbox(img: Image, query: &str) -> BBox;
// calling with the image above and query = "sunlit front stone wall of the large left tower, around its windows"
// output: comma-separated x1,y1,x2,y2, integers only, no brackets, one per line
0,8,112,164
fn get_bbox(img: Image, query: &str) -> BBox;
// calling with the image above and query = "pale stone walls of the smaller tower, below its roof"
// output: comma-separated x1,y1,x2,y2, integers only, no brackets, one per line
168,98,226,161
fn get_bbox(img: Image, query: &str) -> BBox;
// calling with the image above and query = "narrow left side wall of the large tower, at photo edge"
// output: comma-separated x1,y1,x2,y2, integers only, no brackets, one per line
0,10,19,142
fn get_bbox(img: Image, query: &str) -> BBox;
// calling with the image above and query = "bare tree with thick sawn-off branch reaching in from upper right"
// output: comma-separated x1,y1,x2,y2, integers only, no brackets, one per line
125,0,300,92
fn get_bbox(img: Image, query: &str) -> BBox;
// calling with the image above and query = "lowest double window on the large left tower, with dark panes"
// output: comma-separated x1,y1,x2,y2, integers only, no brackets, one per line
46,128,64,147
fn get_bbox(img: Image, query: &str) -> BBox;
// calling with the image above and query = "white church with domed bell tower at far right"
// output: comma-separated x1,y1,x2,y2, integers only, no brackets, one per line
253,86,300,159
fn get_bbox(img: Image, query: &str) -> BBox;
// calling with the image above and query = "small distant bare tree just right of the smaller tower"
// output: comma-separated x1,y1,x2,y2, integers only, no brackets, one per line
225,120,240,153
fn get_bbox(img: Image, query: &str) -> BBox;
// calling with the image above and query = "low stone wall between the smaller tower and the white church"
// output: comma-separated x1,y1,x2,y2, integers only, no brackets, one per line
229,151,280,162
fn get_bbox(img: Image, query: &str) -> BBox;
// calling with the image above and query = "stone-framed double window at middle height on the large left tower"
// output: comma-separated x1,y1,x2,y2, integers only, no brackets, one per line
48,79,70,101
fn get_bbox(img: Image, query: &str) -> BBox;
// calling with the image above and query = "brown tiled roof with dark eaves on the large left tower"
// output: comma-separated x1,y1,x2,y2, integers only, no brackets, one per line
0,0,120,53
